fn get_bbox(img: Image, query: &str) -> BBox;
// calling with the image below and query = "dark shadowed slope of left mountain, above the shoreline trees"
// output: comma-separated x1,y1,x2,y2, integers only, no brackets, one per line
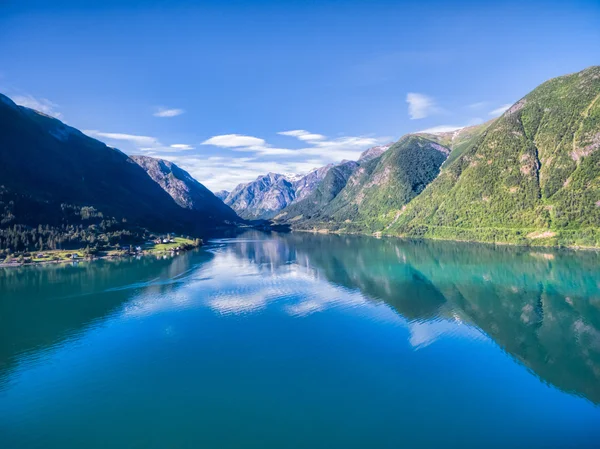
0,95,188,225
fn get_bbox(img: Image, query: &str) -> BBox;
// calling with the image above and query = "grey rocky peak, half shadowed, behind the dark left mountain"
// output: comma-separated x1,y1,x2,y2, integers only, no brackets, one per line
131,156,240,223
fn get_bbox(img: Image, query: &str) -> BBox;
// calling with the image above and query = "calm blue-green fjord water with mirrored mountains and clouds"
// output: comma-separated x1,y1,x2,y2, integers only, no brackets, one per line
0,232,600,449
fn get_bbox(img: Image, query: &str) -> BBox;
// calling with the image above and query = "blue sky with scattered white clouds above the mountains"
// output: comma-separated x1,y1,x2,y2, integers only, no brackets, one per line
0,0,600,190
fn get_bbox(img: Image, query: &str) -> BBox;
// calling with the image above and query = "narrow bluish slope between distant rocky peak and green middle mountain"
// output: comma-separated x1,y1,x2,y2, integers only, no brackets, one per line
275,161,358,222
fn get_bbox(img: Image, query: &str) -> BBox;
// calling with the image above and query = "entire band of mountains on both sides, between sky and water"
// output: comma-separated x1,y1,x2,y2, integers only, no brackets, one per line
0,66,600,249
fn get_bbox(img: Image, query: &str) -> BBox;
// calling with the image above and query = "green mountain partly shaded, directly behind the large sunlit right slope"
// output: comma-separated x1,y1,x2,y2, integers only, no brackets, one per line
293,135,450,232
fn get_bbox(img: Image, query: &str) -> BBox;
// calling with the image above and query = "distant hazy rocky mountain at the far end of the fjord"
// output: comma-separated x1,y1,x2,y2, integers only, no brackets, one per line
225,173,296,220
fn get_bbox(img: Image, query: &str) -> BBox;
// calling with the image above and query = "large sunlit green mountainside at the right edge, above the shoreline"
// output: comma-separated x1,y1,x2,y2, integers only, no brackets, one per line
388,67,600,246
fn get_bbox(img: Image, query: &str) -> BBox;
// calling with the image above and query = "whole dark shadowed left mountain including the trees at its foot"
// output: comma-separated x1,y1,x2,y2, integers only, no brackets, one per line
0,94,238,249
